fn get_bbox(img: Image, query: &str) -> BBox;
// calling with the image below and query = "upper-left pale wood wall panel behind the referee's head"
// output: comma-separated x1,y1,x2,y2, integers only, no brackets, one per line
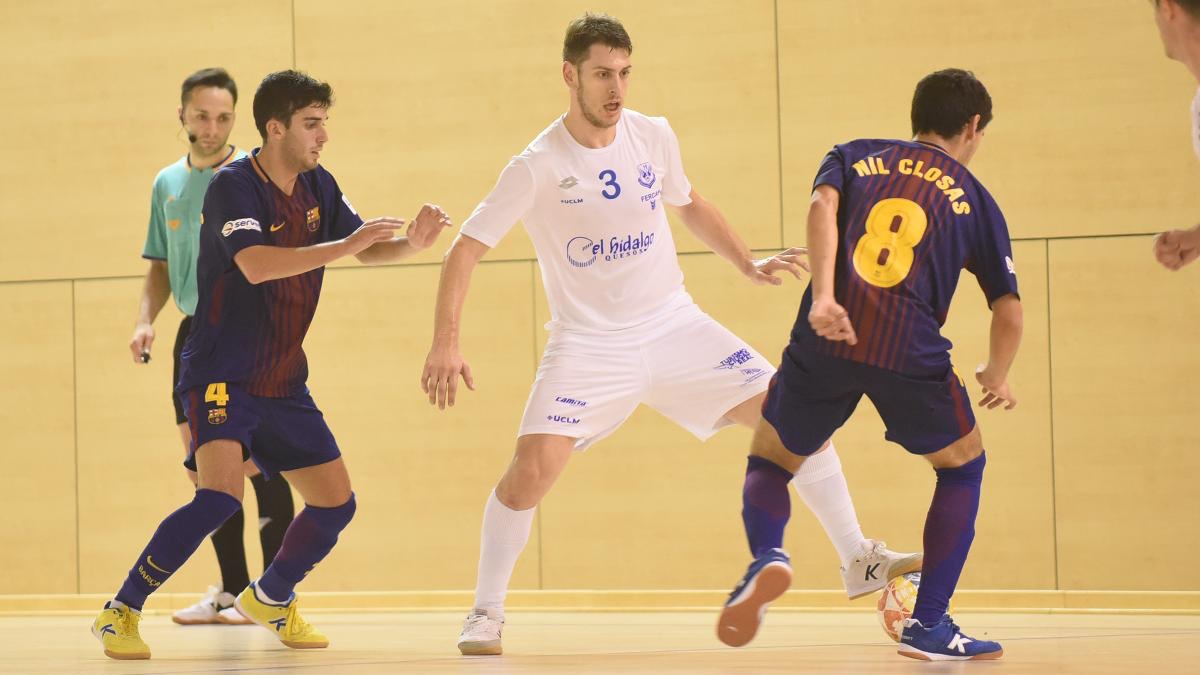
0,0,292,281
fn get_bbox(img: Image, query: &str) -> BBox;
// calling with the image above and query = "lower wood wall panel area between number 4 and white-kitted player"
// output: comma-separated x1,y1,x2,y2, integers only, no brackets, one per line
306,262,539,591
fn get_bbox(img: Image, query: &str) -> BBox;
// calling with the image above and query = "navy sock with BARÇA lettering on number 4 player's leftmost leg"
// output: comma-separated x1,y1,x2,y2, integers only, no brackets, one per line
116,489,241,611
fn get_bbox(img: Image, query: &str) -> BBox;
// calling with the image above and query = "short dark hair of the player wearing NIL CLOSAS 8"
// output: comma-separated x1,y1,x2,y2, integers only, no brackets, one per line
912,68,991,138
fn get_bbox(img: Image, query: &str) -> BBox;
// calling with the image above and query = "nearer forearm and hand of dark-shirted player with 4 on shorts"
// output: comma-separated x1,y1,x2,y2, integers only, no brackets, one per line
233,217,404,283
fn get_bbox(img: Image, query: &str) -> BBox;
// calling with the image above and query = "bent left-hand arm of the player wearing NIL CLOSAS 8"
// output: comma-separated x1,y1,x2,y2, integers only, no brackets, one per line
808,185,858,345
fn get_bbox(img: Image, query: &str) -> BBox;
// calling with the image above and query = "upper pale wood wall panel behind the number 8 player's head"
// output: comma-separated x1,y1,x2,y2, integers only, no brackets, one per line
779,0,1200,244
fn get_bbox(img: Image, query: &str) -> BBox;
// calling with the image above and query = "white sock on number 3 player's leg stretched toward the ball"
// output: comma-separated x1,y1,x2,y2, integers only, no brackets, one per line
792,443,865,567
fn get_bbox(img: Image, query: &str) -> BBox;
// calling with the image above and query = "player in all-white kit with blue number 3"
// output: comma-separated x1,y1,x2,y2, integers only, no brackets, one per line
421,14,920,655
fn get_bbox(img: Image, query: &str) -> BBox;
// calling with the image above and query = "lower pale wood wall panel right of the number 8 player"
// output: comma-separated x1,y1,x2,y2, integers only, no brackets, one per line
1050,237,1200,591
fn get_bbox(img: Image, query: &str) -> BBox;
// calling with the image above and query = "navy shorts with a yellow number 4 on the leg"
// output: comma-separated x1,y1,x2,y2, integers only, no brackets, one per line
179,382,342,477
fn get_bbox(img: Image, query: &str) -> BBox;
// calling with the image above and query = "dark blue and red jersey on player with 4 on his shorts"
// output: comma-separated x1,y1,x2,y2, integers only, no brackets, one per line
178,150,362,398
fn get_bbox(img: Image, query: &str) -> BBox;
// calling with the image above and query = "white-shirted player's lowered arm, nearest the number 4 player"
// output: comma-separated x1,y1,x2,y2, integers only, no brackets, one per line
421,234,490,410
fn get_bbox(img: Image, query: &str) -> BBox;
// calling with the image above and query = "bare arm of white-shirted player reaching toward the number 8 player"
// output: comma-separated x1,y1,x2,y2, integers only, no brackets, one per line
676,190,809,286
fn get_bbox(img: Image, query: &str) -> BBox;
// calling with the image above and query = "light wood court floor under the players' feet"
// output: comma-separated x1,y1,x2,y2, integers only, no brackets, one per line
0,611,1200,675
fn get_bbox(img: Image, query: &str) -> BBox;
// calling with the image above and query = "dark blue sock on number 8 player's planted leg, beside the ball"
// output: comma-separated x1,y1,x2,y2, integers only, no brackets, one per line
912,454,988,626
